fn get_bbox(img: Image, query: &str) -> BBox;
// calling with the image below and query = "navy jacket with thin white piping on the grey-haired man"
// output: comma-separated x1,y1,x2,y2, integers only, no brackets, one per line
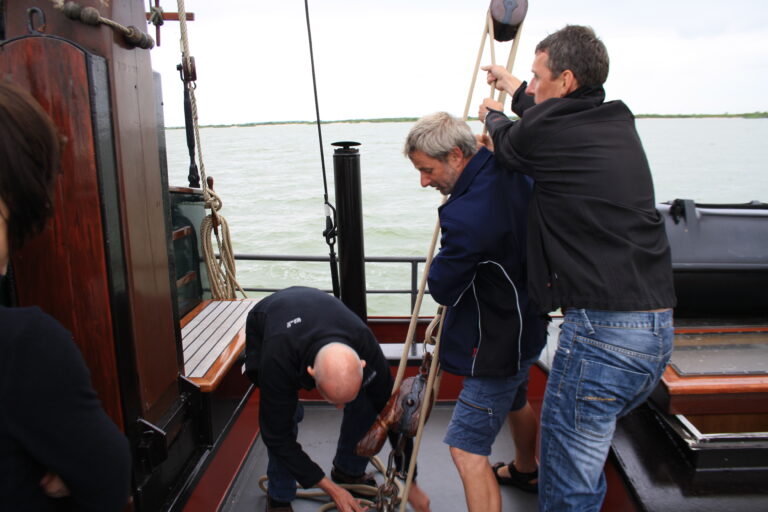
429,149,546,377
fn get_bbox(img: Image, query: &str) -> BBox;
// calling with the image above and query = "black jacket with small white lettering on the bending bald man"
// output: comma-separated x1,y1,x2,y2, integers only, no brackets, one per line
245,286,393,487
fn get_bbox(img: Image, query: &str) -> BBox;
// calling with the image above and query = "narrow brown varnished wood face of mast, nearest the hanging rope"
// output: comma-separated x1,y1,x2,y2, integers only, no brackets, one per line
110,1,181,421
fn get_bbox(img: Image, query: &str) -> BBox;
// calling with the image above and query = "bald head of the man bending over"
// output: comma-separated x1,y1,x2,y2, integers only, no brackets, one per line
307,342,365,405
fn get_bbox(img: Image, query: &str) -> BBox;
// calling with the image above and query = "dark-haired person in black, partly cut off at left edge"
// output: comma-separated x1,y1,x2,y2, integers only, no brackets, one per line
0,79,131,512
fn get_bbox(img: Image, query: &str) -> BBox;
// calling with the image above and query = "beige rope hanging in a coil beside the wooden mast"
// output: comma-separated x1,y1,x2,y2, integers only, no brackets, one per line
178,0,247,300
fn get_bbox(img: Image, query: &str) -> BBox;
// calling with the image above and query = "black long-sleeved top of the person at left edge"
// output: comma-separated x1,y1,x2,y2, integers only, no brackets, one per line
0,307,131,512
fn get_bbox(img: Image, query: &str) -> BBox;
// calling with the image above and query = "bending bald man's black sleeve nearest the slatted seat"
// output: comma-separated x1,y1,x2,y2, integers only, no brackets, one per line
259,338,325,488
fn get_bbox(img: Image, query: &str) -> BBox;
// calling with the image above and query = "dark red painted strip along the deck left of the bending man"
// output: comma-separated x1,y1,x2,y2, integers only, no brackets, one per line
183,390,259,512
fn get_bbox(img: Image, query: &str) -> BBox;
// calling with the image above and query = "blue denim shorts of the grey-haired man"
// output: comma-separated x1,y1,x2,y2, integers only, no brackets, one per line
443,354,539,455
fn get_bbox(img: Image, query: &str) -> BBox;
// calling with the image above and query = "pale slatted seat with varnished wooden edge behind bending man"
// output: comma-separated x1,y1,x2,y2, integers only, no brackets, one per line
181,299,257,393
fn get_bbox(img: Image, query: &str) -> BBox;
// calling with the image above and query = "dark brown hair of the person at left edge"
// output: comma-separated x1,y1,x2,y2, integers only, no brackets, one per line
0,80,61,248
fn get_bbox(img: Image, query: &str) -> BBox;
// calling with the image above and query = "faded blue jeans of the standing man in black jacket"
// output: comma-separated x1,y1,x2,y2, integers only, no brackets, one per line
539,309,674,512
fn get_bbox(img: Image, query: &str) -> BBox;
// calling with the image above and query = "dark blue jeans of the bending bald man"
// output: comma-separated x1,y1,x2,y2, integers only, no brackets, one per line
267,391,377,502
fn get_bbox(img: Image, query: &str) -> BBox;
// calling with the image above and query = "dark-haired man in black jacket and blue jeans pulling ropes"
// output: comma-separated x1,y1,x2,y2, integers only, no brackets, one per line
480,26,675,512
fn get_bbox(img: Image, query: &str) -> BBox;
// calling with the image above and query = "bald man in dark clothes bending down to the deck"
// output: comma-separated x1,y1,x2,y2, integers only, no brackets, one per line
245,286,429,512
